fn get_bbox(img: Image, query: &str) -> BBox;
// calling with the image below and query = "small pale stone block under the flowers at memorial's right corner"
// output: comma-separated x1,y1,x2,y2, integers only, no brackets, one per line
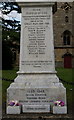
53,106,67,114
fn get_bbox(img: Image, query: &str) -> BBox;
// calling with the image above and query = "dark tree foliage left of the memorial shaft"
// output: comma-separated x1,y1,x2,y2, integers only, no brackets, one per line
0,2,21,69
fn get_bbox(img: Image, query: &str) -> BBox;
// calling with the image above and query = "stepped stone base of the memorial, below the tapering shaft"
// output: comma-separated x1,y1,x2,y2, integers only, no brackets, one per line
7,74,66,113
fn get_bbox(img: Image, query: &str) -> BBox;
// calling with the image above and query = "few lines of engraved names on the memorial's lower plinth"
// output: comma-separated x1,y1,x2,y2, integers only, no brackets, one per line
20,89,49,105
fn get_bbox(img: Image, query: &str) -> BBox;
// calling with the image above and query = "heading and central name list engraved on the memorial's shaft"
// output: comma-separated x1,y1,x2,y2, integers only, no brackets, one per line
24,8,50,57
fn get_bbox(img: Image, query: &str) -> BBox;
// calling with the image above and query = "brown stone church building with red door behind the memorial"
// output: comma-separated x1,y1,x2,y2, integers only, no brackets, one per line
53,2,74,68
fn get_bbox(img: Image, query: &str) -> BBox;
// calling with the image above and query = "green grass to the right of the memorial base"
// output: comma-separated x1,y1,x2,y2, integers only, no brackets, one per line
56,68,74,111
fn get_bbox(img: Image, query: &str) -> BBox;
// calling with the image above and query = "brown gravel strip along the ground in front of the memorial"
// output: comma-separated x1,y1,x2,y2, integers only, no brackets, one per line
2,113,72,120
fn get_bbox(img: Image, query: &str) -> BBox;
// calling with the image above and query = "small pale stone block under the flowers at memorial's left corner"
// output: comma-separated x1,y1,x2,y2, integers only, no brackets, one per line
6,106,21,114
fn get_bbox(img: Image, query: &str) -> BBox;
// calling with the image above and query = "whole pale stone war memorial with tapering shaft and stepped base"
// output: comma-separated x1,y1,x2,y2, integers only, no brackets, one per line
7,0,66,113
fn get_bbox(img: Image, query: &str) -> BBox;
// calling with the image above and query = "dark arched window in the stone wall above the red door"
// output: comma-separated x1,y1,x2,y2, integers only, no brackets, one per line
63,30,71,45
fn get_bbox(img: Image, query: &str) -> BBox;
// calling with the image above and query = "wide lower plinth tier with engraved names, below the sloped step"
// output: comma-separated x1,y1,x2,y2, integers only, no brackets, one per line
8,82,66,112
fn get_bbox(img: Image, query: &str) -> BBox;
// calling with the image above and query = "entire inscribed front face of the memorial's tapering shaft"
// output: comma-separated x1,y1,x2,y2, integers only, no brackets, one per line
21,7,53,71
